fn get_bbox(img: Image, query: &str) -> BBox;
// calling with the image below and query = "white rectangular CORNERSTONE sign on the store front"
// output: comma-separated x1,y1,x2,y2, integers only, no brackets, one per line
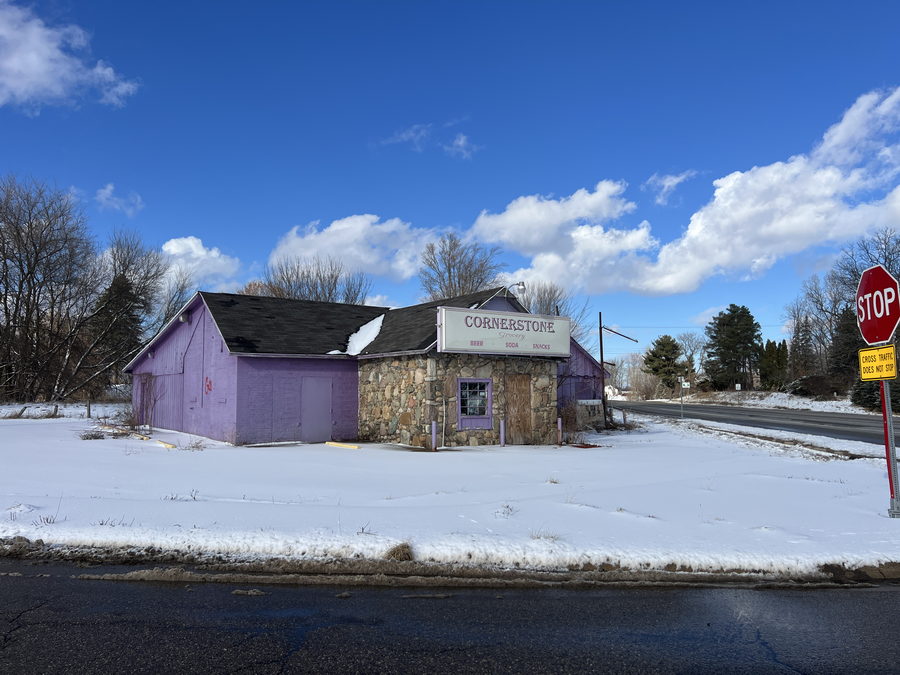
437,307,571,356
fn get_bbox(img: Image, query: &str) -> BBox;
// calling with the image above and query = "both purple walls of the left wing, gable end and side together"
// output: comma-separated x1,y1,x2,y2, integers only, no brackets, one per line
132,297,359,444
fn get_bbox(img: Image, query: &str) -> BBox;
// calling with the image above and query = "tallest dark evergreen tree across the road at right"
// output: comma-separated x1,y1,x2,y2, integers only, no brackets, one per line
705,304,762,389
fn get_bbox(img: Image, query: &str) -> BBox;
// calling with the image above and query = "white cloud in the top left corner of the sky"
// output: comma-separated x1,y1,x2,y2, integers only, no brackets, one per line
0,0,138,112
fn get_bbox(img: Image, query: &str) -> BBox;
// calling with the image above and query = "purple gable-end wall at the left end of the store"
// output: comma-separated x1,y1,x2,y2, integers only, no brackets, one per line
132,298,237,442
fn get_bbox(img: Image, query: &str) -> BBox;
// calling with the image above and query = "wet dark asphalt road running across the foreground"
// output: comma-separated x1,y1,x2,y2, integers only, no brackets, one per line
0,560,900,673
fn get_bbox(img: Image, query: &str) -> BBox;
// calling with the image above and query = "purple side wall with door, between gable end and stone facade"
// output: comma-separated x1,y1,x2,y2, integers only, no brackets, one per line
234,357,359,444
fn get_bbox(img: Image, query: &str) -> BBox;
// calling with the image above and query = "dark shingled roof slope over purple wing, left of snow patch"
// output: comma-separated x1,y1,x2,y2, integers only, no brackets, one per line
200,291,388,354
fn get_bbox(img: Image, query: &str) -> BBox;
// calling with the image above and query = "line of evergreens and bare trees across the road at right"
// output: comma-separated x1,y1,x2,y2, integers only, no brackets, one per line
636,228,900,407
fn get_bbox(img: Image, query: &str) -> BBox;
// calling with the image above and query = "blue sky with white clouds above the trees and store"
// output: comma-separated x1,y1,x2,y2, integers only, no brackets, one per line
0,0,900,358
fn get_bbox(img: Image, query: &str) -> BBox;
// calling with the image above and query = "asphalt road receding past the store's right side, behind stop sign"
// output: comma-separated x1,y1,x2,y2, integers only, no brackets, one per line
610,401,900,444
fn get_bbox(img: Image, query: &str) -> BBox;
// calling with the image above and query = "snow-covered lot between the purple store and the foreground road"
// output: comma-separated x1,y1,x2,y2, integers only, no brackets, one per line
0,404,900,574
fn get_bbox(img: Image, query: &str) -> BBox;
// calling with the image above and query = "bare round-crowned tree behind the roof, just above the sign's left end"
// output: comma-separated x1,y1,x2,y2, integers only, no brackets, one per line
419,232,503,300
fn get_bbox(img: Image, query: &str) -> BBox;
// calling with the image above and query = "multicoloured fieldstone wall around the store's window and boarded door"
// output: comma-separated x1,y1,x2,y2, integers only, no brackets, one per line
358,352,558,449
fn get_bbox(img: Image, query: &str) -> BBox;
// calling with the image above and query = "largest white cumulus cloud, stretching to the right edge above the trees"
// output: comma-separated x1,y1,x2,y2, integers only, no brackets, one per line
488,88,900,295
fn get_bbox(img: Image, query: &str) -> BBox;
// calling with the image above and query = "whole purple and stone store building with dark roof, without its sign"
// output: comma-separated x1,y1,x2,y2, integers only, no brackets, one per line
126,288,602,447
